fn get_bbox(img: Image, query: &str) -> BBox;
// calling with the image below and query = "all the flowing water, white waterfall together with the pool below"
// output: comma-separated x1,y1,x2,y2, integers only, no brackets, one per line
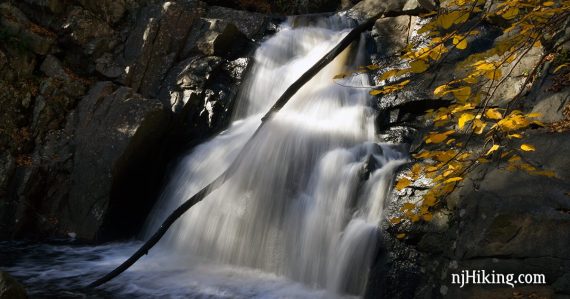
0,17,407,298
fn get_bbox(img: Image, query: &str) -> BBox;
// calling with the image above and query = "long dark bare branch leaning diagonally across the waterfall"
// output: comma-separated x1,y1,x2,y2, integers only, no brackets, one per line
87,8,427,288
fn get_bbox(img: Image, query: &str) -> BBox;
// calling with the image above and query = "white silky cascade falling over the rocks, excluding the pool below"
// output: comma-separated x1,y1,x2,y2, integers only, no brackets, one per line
146,18,404,295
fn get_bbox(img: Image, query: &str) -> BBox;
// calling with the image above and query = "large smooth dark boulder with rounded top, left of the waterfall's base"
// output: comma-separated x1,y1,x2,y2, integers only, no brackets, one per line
60,82,169,240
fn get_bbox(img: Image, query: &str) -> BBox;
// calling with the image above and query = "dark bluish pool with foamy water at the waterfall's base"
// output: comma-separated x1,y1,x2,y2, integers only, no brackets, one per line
0,242,356,299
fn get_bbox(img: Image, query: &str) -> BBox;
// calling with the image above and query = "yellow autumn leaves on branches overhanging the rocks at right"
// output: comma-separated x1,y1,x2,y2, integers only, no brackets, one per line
371,0,570,230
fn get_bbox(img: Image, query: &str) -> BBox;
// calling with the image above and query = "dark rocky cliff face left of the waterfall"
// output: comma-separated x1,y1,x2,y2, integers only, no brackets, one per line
0,0,270,241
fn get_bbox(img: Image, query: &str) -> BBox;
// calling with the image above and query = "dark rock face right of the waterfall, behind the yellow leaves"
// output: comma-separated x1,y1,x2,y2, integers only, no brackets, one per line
348,1,570,298
